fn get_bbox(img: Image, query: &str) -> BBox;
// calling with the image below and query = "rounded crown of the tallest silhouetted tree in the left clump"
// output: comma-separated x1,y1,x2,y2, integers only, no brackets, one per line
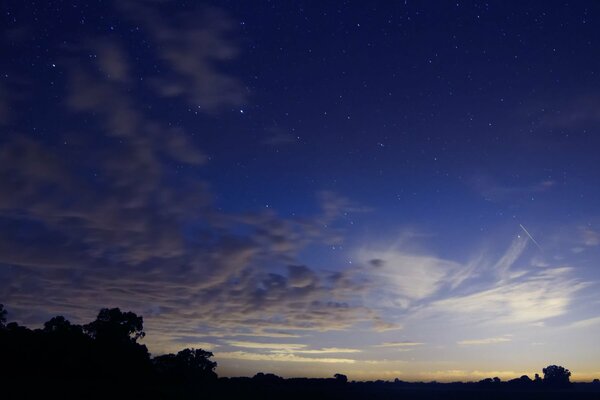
83,308,146,343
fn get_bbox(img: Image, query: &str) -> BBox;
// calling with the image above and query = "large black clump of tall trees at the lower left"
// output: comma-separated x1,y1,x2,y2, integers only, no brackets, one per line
0,304,217,398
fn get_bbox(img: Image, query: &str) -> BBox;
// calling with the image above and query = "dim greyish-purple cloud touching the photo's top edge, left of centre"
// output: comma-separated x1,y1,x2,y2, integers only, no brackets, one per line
118,1,247,112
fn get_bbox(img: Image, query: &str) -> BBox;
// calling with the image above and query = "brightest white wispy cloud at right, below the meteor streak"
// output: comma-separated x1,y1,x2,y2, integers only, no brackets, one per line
359,234,589,332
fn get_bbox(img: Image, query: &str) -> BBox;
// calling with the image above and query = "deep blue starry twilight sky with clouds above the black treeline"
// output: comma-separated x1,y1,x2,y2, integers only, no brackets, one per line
0,0,600,381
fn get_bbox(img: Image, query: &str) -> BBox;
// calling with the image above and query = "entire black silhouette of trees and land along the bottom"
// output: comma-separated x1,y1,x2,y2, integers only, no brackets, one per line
0,304,600,399
